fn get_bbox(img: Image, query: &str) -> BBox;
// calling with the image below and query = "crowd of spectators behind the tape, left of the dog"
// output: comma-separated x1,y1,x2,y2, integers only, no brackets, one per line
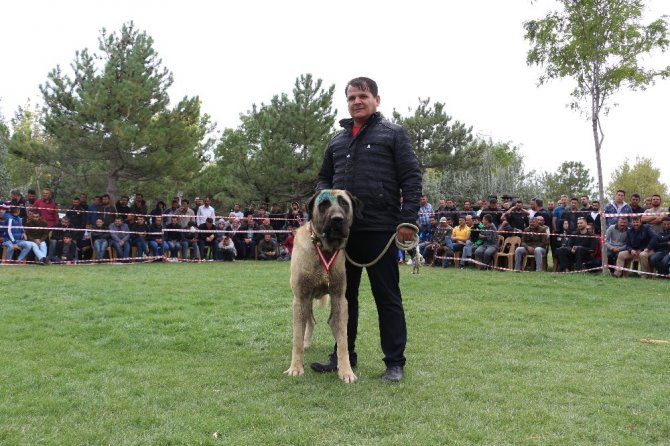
0,188,307,264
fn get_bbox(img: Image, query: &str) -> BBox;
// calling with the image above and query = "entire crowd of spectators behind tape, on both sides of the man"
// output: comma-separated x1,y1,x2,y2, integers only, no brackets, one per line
0,188,670,277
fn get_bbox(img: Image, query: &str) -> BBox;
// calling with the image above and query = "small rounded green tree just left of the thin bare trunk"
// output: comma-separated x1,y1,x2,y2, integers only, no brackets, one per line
542,161,604,200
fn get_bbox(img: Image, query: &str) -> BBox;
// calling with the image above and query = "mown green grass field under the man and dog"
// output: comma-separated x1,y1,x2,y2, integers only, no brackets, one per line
0,262,670,445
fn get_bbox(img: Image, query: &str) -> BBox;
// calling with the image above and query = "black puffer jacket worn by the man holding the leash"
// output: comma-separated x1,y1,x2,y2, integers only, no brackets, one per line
317,113,421,232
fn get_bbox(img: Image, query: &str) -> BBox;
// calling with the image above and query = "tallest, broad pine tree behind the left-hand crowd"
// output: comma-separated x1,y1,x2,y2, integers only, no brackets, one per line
40,22,211,200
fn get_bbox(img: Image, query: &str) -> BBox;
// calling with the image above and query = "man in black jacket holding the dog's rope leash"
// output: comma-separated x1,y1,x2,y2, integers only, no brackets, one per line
311,77,420,381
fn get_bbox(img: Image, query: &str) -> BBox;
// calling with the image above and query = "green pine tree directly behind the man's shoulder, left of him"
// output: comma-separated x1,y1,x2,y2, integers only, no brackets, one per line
216,74,337,204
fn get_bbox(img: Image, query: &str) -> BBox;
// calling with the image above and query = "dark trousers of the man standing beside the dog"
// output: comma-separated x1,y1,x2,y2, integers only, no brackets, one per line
332,232,407,366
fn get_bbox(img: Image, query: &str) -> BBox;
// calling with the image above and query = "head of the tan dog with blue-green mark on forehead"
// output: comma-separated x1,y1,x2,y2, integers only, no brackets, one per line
307,189,361,250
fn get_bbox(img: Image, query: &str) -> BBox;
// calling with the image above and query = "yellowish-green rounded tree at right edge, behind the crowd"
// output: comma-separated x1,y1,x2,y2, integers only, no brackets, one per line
607,157,668,199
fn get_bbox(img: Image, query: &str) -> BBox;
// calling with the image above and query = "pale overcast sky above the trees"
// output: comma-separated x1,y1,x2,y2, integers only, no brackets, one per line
0,0,670,192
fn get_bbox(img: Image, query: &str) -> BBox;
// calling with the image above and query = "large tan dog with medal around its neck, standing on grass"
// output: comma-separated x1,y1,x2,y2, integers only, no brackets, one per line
284,189,360,383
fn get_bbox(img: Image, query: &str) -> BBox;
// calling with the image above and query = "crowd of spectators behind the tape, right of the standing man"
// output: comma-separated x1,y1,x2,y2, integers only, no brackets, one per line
406,190,670,277
